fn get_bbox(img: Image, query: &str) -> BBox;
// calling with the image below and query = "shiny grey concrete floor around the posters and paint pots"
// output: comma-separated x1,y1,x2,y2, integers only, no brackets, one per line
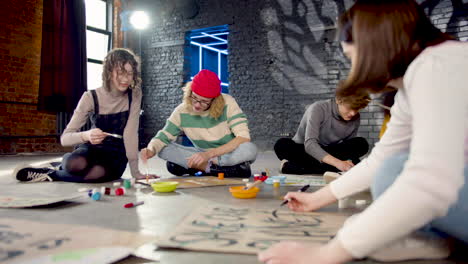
0,152,468,264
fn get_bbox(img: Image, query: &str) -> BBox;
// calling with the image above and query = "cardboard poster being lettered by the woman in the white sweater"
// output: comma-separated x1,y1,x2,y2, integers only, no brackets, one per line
155,205,347,254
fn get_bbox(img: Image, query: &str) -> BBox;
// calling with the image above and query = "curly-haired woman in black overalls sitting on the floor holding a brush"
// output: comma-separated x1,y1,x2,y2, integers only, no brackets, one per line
14,48,157,182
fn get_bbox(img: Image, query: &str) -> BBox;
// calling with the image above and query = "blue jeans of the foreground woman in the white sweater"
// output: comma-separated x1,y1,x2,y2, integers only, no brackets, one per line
371,152,468,243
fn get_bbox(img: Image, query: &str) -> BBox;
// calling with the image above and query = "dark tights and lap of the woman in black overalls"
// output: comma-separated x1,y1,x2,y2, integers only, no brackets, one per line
51,147,127,183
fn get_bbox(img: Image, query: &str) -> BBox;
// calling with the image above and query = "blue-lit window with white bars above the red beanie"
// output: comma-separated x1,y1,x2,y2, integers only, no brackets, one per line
188,25,229,93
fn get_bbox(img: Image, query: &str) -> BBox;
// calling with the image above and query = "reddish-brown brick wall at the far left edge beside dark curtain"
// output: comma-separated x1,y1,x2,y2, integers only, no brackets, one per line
0,0,62,154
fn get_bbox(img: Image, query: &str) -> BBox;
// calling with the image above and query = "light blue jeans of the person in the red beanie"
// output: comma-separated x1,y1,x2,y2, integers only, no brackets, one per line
159,142,257,169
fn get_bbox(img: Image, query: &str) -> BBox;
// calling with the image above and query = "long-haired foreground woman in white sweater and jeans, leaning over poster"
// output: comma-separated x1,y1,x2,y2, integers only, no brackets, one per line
259,0,468,264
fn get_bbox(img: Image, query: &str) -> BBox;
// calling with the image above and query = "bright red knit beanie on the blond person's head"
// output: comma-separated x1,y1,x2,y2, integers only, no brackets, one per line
192,70,221,98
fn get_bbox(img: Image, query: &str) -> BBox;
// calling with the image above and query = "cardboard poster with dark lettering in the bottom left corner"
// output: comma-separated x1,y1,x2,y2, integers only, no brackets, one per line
0,218,154,263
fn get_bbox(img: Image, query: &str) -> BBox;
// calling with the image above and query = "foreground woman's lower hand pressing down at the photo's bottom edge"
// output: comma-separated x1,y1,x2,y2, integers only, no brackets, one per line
257,241,343,264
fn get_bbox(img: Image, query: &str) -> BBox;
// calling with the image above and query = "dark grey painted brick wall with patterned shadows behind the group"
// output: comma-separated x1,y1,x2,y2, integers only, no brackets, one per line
135,0,468,150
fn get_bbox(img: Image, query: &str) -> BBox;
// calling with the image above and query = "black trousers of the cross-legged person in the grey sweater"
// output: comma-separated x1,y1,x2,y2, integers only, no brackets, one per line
274,137,369,174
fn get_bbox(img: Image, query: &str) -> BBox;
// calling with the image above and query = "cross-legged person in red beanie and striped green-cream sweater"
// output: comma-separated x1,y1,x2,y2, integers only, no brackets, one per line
141,70,257,178
